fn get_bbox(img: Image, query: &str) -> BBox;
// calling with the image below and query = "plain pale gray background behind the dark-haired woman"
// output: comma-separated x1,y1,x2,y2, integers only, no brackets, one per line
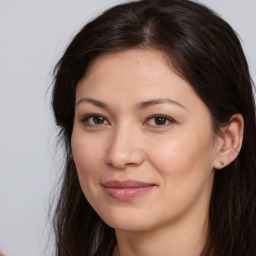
0,0,256,256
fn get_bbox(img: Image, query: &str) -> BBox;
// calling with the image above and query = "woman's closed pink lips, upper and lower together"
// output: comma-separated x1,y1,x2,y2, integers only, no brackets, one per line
103,180,155,200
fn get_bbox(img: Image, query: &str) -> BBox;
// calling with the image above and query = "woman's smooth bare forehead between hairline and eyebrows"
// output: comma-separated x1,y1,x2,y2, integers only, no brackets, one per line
76,49,201,110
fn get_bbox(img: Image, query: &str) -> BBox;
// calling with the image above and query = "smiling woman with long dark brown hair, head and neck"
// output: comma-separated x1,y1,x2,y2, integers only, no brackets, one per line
52,0,256,256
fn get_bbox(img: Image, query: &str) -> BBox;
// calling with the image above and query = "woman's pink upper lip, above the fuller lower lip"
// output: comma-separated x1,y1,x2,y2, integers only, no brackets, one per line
102,180,154,188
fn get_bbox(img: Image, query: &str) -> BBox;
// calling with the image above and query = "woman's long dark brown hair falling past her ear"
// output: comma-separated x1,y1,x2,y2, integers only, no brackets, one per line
52,0,256,256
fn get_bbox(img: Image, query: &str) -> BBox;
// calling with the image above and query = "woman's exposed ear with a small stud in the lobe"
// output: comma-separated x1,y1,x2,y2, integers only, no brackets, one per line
214,114,244,169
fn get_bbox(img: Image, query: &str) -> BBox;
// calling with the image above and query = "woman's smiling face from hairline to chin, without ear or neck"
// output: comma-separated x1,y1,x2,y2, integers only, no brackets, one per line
72,49,218,231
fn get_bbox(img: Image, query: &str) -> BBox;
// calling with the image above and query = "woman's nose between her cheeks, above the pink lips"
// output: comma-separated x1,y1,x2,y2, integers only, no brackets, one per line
106,126,145,169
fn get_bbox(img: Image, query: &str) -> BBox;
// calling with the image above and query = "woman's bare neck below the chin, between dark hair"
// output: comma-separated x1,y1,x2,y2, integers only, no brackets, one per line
113,211,208,256
